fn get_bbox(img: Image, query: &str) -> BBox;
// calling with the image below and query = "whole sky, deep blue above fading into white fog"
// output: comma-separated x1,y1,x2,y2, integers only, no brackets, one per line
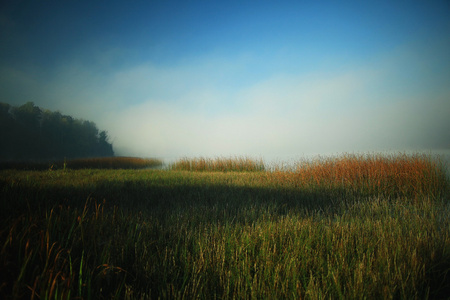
0,0,450,160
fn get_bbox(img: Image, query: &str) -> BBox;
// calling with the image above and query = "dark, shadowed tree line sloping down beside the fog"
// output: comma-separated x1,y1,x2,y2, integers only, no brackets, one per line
0,102,114,160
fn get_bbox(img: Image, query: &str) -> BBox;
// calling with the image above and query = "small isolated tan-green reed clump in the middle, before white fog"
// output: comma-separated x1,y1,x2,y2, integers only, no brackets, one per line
169,157,265,172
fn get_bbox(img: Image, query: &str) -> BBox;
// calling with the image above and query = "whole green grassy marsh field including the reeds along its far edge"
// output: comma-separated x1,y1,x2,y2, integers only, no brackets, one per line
0,154,450,299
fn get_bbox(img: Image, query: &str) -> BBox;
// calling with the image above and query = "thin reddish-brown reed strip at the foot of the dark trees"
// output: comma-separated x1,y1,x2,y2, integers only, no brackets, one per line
63,157,162,169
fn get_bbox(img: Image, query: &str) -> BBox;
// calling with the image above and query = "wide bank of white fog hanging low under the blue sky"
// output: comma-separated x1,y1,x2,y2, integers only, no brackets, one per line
0,35,450,159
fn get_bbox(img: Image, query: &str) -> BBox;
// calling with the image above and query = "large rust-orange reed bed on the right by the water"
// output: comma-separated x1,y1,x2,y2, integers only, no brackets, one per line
271,154,447,198
